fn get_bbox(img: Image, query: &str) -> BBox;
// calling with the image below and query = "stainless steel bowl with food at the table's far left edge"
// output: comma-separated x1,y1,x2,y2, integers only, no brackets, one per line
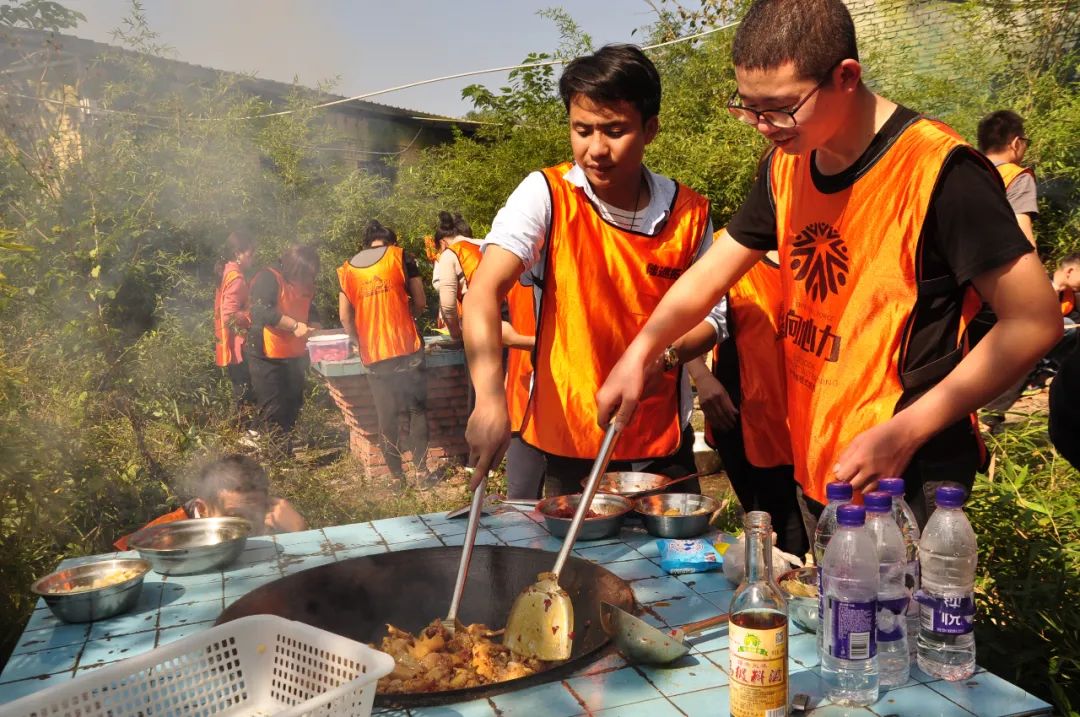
30,558,150,622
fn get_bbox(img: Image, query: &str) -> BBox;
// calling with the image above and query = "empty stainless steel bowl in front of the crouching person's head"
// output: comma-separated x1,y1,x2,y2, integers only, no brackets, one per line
127,518,252,576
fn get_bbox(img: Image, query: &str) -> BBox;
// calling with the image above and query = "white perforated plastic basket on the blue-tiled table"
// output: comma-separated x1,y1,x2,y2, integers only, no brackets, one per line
0,615,394,717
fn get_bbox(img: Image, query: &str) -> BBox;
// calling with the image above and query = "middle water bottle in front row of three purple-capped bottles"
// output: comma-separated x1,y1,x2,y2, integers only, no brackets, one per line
865,491,912,687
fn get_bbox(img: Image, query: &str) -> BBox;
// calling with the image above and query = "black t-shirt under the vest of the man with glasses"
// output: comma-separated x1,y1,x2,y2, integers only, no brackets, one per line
727,107,1031,479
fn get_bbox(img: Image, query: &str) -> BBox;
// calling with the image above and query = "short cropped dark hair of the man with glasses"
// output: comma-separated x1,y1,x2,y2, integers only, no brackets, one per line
731,0,859,82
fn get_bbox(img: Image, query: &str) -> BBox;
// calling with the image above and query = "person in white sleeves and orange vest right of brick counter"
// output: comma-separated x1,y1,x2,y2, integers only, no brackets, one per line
431,212,481,341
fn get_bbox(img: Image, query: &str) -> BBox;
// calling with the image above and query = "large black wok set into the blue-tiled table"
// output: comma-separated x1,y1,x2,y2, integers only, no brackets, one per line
217,545,634,707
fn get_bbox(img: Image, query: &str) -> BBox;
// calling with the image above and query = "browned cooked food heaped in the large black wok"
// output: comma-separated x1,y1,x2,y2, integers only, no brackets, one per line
377,620,551,694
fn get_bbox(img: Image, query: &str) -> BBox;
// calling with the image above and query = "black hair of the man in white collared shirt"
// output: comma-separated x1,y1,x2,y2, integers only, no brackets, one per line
558,44,660,124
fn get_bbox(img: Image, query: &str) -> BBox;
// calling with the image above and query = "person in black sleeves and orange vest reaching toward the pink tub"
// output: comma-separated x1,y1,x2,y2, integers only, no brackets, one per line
244,246,319,434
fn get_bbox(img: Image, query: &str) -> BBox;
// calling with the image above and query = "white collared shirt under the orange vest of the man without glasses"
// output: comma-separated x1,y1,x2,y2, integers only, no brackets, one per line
482,164,728,428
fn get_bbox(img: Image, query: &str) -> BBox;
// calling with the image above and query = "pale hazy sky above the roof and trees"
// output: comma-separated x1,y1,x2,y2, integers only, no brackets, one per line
63,0,659,117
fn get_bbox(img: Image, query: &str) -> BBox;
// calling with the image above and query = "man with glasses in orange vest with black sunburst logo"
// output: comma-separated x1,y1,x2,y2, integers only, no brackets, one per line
596,0,1062,532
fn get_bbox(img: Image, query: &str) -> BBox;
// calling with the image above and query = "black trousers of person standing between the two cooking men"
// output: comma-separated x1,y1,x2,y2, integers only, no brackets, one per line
713,419,810,556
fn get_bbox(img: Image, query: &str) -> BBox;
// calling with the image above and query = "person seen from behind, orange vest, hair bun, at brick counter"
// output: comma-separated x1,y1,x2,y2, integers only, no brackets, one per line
338,219,440,487
